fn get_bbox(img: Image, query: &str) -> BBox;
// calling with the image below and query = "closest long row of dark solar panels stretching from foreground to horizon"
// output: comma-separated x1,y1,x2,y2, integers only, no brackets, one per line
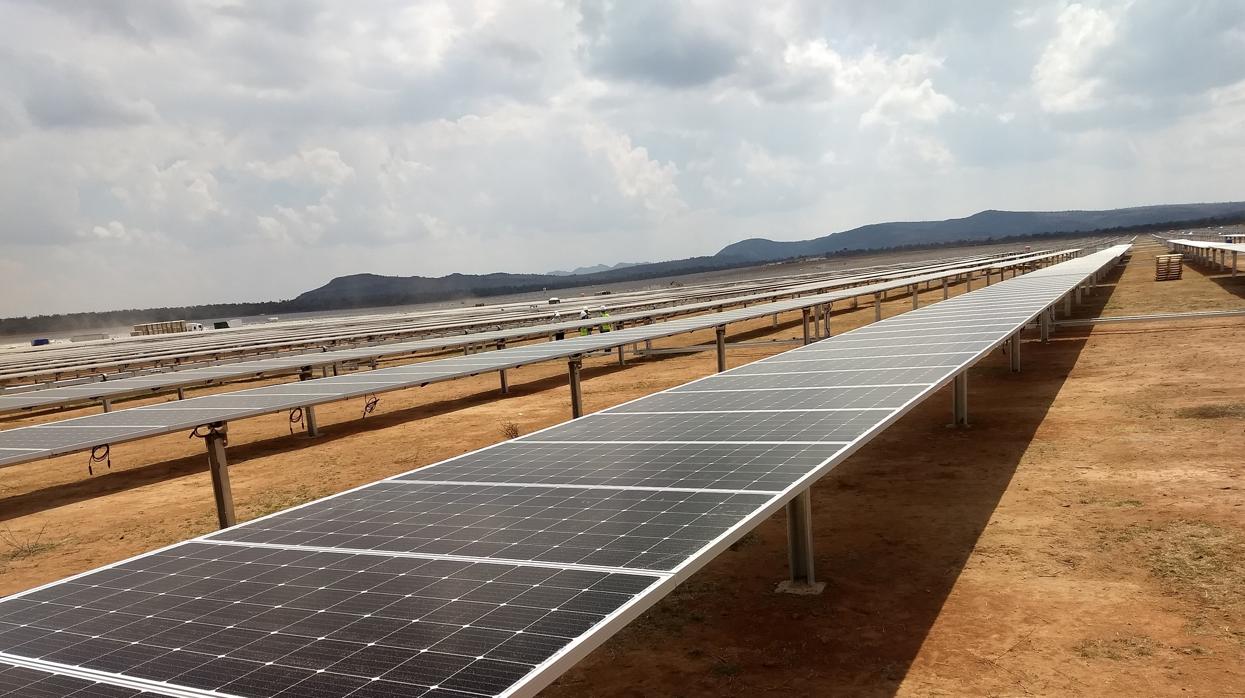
0,246,1127,698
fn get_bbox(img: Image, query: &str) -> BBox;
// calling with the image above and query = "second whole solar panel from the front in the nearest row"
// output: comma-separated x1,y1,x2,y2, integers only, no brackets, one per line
207,480,771,571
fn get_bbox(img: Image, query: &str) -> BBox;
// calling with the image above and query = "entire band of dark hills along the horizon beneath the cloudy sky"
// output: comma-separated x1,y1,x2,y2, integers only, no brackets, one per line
0,202,1245,336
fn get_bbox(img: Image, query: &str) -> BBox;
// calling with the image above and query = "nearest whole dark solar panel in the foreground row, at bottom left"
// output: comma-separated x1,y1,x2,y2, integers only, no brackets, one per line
0,542,660,697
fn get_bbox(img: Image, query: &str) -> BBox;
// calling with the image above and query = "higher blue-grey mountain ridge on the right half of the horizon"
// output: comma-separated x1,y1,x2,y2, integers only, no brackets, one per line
717,202,1245,261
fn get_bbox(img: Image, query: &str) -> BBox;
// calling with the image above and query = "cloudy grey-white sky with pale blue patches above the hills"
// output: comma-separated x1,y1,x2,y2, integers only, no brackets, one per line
0,0,1245,316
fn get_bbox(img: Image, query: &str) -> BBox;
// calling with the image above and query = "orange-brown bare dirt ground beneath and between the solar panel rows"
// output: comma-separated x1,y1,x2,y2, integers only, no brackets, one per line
0,236,1245,697
